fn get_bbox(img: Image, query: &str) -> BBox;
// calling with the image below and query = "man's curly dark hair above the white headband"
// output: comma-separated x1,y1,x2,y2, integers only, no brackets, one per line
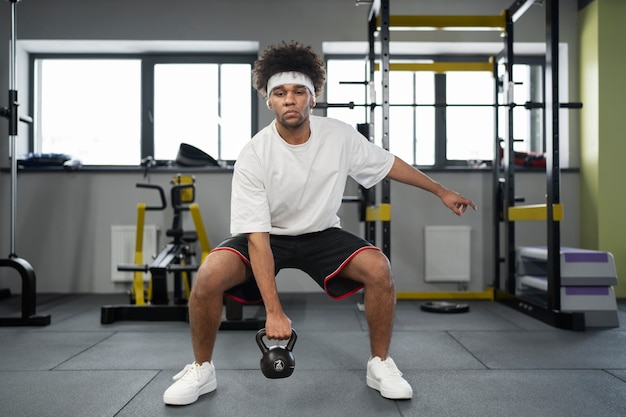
252,41,326,97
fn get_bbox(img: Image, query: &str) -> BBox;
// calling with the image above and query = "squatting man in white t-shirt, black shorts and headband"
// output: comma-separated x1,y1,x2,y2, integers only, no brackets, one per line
163,42,476,405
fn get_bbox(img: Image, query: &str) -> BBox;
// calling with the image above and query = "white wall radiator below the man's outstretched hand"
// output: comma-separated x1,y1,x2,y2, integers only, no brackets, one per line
424,226,472,282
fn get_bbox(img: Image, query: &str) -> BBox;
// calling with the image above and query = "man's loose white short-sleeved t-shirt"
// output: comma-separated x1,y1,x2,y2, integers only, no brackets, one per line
230,115,395,236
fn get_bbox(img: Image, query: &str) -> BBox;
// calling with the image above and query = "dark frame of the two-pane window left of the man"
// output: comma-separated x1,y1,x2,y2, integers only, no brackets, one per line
28,52,259,167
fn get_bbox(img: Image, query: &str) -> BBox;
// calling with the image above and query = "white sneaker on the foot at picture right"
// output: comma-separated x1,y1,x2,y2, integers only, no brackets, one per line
367,356,413,400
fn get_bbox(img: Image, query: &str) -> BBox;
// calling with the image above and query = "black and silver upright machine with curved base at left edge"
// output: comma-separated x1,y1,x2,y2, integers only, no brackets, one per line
0,0,50,326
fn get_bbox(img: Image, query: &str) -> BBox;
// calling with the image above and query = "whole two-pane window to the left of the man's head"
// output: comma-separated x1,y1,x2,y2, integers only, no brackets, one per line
32,55,256,165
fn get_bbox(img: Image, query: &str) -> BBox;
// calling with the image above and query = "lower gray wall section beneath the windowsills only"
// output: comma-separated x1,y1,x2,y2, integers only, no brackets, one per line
0,166,578,293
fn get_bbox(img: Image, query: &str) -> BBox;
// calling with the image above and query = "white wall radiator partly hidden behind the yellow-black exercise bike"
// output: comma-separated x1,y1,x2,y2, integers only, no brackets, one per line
111,224,159,282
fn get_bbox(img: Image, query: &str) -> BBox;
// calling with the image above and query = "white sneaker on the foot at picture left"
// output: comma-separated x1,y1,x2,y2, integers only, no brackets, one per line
163,362,217,405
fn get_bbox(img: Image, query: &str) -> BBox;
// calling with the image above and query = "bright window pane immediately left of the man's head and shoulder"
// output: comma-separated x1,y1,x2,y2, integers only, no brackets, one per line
154,64,251,160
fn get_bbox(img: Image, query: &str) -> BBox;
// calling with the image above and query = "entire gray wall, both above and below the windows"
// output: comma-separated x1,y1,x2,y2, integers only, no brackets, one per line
0,0,578,292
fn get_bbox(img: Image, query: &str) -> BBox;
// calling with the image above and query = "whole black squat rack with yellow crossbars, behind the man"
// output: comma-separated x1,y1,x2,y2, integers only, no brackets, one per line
364,0,585,330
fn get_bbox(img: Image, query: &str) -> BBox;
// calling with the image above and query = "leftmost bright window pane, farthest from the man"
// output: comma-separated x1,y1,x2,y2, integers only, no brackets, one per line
34,59,141,165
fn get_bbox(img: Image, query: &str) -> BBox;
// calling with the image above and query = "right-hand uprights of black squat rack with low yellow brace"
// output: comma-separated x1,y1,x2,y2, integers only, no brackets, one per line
493,0,585,330
